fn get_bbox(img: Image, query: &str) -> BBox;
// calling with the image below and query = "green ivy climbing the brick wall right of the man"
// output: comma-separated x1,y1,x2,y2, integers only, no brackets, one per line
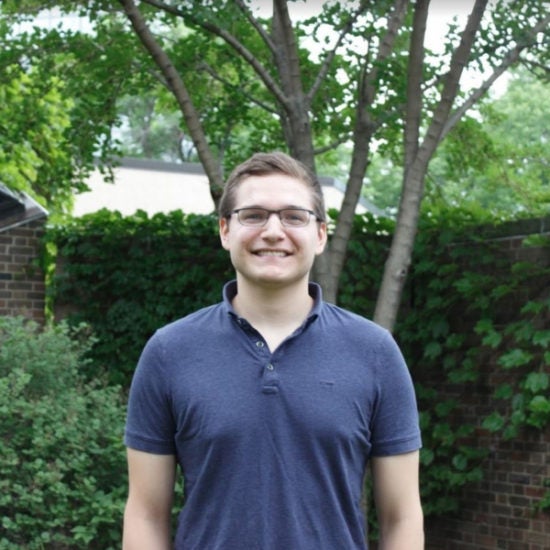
339,211,550,515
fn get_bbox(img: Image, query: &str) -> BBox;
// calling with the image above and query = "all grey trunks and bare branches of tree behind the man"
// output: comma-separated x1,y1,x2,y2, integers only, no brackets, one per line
106,0,549,328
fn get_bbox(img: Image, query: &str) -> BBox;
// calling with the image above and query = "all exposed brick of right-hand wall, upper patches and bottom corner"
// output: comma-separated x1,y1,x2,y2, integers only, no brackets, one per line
417,219,550,550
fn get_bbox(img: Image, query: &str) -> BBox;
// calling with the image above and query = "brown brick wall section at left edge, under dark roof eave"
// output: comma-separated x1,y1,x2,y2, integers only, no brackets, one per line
0,219,45,323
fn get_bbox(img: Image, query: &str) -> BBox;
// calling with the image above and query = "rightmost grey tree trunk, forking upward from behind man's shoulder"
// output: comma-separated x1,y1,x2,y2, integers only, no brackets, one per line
375,0,550,327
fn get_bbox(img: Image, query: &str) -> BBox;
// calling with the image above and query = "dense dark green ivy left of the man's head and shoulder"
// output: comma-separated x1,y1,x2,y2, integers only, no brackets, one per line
48,210,232,387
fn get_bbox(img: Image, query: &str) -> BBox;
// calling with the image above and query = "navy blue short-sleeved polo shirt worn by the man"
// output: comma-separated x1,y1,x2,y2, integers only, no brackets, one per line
125,281,421,550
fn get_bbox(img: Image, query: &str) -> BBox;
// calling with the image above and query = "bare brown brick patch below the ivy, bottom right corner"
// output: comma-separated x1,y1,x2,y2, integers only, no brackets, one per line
426,384,550,550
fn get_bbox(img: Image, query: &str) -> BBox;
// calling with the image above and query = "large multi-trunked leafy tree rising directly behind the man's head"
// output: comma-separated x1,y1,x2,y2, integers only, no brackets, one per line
4,0,550,329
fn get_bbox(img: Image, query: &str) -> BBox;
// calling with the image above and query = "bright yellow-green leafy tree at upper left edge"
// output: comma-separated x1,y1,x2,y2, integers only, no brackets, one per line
0,1,146,215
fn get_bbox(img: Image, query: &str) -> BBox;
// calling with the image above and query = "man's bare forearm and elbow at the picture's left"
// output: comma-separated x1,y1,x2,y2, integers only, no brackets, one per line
122,449,176,550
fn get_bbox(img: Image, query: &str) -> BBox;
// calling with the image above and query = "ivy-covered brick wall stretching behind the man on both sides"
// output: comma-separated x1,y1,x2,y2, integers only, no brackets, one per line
48,211,550,550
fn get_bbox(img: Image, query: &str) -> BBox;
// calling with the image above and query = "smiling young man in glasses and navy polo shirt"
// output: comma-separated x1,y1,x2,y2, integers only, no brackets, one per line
123,153,423,550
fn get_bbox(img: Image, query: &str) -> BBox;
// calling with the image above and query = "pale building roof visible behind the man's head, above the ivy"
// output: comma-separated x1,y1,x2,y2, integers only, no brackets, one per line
73,158,381,216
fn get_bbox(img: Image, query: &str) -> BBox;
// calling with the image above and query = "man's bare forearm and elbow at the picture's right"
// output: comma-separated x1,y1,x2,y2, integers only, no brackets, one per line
372,451,424,550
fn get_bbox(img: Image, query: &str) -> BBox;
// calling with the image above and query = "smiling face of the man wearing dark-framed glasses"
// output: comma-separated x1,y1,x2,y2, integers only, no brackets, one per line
220,174,327,288
